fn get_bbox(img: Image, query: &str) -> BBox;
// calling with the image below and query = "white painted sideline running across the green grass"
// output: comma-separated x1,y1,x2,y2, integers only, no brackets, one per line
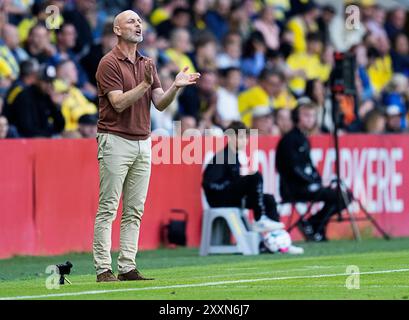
0,269,409,300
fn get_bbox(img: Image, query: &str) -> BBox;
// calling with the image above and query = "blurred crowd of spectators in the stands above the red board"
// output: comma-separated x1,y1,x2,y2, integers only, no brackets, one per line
0,0,409,138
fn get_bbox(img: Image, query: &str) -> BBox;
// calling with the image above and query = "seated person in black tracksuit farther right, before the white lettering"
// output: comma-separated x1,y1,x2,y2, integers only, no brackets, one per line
276,98,345,241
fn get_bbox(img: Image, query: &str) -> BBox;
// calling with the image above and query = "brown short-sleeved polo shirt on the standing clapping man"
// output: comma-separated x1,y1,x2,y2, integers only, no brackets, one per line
96,46,161,140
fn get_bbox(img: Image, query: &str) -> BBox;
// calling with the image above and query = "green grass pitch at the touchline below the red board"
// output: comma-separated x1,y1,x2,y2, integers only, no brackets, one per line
0,238,409,300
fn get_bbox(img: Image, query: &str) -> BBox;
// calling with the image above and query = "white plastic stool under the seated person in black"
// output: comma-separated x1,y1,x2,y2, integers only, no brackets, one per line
199,208,261,256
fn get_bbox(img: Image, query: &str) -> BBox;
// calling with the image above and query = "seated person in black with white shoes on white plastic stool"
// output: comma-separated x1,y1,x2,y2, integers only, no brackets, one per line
202,122,284,232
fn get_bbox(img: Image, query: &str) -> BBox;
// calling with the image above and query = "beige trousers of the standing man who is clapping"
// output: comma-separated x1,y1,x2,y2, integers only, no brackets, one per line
93,133,151,274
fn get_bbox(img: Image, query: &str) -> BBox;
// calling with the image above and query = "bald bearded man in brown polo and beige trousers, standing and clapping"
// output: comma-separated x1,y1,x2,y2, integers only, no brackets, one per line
93,10,200,282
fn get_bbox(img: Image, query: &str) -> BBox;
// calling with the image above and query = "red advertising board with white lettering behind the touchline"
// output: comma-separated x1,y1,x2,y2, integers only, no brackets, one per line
0,135,409,258
